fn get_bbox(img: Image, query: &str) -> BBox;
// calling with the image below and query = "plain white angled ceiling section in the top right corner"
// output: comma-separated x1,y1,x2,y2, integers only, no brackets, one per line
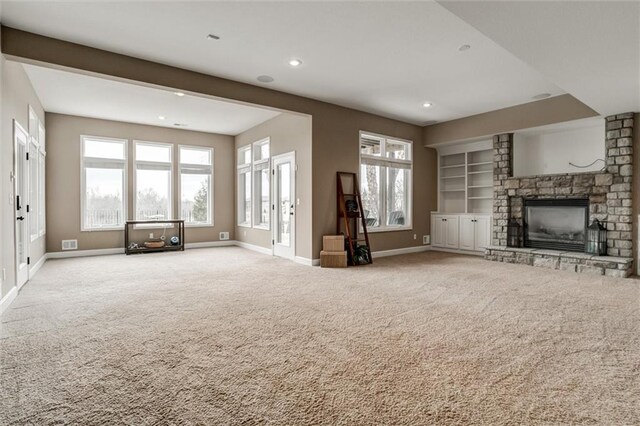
441,1,640,115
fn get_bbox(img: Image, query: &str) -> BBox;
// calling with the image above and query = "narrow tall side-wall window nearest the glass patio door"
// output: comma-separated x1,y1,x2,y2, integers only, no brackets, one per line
253,138,271,229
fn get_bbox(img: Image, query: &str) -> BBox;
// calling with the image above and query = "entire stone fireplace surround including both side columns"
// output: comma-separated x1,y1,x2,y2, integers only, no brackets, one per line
492,113,634,257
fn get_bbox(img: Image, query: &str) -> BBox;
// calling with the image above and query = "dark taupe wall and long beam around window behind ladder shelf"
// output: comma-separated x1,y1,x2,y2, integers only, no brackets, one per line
2,27,437,258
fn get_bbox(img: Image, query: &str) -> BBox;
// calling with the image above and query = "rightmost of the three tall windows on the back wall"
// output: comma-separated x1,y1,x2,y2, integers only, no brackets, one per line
179,146,213,226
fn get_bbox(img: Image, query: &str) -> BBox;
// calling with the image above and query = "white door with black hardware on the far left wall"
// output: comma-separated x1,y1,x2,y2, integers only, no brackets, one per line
13,120,29,288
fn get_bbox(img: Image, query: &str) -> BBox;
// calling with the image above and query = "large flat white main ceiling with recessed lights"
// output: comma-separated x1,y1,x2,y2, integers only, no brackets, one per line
2,1,565,125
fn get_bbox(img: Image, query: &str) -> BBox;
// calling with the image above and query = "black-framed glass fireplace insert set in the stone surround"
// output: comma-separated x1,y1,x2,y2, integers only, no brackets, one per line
524,198,589,252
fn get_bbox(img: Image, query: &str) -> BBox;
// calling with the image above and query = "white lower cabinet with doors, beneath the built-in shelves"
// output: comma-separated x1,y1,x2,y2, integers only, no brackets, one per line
431,213,491,252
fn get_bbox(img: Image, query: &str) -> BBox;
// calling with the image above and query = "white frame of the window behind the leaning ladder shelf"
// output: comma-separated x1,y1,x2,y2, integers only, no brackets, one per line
358,130,413,233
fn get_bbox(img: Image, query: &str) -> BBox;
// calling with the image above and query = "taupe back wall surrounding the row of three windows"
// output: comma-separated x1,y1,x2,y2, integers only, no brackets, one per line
47,113,234,252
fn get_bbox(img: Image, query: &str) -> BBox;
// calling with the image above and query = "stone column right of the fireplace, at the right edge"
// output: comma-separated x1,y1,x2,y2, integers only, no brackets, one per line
606,112,634,257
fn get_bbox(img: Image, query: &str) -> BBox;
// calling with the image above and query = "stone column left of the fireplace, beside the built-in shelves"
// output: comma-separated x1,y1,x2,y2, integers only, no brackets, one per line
492,133,513,246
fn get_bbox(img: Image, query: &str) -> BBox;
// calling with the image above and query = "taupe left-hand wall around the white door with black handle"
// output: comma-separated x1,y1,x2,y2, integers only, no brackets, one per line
0,57,45,298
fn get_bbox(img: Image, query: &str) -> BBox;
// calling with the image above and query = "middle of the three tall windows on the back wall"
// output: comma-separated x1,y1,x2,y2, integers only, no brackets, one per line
134,141,173,220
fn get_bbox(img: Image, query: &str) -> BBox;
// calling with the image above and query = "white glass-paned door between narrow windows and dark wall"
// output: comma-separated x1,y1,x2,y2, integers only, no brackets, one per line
272,152,296,259
